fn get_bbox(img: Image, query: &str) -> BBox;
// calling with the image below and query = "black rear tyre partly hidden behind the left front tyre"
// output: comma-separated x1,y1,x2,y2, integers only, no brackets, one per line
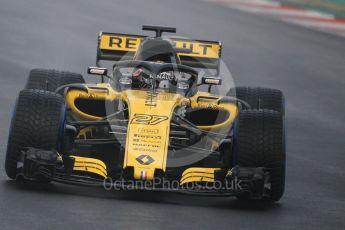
25,69,85,92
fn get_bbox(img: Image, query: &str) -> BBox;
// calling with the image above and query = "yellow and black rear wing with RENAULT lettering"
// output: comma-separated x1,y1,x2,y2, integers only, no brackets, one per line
97,32,222,71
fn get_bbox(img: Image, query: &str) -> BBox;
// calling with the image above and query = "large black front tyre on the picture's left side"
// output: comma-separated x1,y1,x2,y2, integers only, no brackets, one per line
5,89,65,182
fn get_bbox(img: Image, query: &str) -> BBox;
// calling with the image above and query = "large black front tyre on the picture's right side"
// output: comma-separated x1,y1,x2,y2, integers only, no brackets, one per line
233,110,285,202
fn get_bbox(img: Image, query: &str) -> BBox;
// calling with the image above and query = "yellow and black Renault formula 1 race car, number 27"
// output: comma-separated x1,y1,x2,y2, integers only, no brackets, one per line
5,26,285,201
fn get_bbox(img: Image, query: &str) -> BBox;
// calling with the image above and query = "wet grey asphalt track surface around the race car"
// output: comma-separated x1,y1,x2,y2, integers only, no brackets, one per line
0,0,345,230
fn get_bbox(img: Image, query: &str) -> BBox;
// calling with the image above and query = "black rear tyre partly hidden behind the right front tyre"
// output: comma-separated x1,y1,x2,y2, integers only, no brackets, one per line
227,87,285,115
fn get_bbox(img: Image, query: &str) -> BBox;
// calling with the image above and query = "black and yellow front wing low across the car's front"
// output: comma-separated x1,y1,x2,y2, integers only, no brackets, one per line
17,148,269,199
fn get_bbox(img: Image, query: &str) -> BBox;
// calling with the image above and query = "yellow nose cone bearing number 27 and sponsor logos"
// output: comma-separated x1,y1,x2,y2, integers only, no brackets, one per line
124,90,182,180
